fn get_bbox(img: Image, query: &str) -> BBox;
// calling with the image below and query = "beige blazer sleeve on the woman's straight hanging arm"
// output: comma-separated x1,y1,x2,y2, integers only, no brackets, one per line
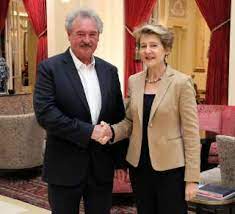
179,78,200,182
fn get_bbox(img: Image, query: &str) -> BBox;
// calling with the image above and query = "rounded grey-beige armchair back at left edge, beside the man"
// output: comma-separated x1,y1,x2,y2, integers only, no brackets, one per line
0,113,44,170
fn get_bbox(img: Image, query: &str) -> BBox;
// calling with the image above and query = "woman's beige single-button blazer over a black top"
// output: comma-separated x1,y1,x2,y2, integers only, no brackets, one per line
113,65,200,182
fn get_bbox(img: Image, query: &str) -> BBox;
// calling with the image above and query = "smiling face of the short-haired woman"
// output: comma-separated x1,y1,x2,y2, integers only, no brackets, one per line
140,34,169,68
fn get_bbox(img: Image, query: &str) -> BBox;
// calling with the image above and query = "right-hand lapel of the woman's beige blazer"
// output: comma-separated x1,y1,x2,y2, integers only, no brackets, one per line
149,66,174,121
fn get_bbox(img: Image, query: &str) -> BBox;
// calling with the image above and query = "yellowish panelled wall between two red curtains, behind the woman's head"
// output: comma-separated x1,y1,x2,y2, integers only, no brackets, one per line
155,0,210,91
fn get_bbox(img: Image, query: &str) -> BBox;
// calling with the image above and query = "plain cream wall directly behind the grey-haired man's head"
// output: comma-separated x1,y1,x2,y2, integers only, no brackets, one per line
47,0,124,91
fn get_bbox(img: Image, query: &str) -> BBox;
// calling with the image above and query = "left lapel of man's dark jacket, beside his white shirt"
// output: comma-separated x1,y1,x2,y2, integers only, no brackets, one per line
64,50,90,114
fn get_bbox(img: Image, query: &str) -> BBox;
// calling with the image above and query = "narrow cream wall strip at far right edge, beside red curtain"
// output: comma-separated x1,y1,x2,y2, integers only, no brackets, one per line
228,1,235,105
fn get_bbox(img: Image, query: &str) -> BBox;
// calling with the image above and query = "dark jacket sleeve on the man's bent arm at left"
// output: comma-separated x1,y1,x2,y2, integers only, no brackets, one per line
33,62,94,147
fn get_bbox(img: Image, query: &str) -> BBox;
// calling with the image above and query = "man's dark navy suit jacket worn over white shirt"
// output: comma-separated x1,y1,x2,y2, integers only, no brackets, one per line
34,50,125,185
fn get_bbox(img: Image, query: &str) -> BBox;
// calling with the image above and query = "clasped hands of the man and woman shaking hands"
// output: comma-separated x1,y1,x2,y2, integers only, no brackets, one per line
91,121,113,145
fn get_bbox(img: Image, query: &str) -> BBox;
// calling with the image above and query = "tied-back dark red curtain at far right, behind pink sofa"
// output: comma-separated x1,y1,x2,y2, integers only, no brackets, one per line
196,0,231,105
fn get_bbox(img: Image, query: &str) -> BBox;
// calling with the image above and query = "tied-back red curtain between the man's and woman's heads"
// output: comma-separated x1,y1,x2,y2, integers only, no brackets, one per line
124,0,156,94
